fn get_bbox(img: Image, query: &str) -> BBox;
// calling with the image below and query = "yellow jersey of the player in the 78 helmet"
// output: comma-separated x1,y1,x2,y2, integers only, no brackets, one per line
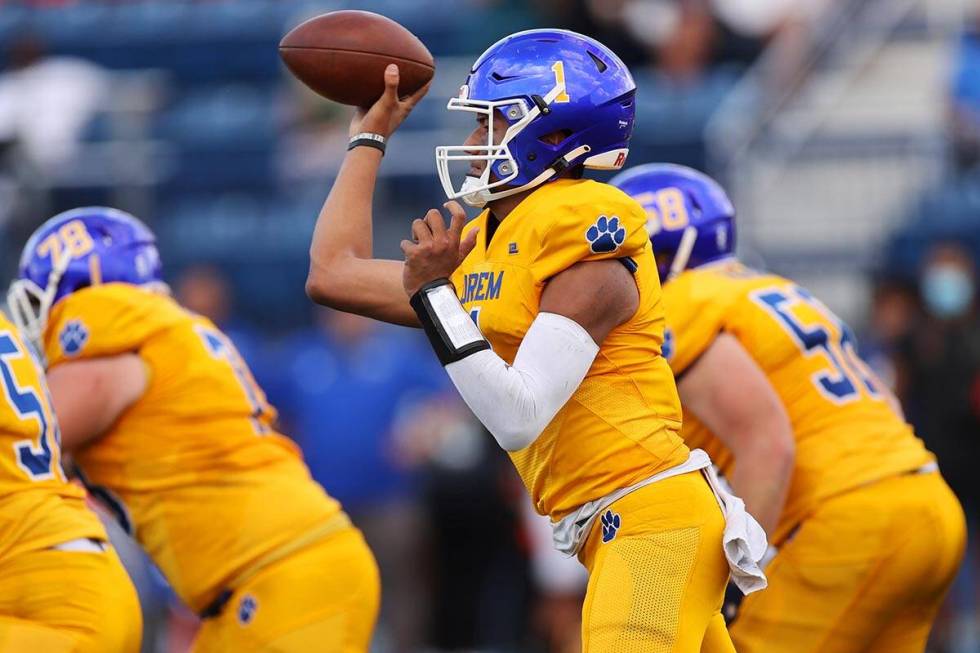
44,283,343,612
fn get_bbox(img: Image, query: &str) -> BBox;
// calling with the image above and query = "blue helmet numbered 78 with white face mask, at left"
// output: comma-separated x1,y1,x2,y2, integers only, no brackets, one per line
7,206,163,343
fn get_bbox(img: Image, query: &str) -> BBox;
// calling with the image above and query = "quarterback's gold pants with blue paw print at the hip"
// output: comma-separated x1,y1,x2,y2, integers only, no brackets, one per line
579,472,735,653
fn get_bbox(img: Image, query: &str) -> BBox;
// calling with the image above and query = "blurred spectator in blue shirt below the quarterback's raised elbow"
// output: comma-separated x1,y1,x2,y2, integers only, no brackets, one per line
267,309,448,652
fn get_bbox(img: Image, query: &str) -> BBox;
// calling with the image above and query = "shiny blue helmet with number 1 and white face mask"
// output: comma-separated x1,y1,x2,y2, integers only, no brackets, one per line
436,29,636,207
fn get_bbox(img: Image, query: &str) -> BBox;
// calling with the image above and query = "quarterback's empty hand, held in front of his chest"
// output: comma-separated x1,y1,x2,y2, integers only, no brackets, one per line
402,202,479,297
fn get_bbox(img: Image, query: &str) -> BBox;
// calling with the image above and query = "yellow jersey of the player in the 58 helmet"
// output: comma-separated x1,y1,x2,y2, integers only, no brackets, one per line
664,259,934,543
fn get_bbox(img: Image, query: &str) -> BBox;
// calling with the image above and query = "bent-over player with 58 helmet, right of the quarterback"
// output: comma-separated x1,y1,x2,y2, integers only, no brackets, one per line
611,164,965,653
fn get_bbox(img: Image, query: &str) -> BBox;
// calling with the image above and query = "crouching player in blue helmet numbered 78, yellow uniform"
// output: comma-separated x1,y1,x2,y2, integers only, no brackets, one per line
9,207,379,653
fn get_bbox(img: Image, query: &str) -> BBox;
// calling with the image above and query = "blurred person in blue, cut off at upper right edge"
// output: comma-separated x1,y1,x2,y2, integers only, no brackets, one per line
949,12,980,170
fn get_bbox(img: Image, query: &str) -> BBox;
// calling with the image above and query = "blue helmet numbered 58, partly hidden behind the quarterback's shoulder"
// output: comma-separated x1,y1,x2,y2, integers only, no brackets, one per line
609,163,735,281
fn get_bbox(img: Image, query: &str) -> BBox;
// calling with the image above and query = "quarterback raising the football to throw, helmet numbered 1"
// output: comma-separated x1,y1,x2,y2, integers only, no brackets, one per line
307,30,765,652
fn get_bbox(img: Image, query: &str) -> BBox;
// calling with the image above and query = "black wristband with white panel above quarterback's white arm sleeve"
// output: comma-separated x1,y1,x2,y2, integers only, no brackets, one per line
410,279,490,366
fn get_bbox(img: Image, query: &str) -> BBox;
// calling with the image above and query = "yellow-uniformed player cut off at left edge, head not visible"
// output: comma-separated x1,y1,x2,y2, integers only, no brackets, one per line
0,313,142,653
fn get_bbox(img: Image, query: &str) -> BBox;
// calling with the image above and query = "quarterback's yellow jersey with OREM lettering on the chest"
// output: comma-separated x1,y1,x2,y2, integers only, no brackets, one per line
452,180,689,520
